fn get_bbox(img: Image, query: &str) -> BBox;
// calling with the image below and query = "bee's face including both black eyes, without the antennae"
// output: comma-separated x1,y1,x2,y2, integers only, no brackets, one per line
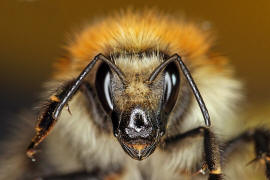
96,59,180,160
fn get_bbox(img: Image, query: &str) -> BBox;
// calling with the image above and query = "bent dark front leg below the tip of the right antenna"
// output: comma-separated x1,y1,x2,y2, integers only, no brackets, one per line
165,127,223,180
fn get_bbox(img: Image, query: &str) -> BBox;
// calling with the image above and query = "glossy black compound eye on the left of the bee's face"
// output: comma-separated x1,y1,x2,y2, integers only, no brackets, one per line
95,63,113,114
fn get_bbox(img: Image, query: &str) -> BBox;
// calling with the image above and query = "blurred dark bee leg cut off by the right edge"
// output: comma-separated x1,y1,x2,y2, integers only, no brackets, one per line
223,129,270,180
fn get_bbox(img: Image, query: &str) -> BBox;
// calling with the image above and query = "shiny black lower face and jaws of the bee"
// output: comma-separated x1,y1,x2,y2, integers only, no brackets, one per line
112,106,160,160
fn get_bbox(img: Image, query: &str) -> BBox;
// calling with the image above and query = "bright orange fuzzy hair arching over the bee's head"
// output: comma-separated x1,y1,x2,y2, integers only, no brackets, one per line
53,10,226,79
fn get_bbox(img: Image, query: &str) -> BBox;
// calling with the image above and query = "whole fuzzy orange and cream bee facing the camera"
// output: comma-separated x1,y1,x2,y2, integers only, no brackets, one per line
0,10,270,180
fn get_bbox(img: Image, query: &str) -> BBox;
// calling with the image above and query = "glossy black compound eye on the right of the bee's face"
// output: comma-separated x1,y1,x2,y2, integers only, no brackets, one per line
163,62,180,113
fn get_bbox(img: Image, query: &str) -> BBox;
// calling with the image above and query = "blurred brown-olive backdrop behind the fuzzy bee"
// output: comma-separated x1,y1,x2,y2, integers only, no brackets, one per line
0,0,270,137
